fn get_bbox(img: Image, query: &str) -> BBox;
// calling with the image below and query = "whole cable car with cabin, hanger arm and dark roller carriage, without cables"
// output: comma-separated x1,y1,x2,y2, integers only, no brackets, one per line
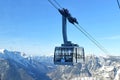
54,8,85,65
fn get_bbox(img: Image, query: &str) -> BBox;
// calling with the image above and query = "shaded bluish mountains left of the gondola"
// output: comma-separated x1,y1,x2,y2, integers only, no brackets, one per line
0,49,54,80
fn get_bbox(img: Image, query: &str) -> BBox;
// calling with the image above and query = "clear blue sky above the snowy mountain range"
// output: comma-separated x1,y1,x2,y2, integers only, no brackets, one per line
0,0,120,55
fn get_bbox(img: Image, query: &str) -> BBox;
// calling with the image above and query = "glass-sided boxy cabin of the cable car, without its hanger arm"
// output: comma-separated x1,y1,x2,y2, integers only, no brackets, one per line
54,46,85,65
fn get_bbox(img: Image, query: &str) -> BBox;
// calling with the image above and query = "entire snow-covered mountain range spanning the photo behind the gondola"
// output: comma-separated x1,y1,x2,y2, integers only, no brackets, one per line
0,49,120,80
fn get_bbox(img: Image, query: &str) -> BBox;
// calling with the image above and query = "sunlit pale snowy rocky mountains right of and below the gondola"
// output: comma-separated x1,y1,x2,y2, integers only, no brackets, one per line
49,55,120,80
